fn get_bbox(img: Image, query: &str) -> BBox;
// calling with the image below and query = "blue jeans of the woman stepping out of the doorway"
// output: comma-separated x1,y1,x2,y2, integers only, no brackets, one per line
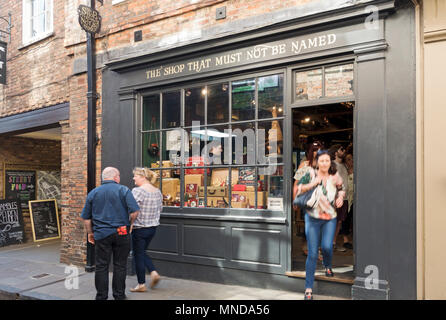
305,214,337,289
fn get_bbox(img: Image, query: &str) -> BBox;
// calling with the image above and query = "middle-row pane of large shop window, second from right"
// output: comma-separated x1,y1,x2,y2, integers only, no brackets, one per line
231,122,256,164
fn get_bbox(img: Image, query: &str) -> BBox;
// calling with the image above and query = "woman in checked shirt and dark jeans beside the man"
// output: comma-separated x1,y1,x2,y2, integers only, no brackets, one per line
130,168,163,292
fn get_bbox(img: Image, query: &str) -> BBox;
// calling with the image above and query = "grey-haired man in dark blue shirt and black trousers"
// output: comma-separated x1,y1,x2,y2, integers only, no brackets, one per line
81,167,139,300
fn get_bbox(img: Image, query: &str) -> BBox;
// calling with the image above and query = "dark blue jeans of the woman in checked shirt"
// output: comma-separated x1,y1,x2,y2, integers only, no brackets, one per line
132,227,156,284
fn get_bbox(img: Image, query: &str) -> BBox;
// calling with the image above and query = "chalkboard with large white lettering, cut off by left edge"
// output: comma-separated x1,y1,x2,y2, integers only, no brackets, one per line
0,200,24,247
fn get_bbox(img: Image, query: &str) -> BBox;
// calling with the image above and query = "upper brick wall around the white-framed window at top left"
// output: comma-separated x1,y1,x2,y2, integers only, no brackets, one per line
0,0,71,117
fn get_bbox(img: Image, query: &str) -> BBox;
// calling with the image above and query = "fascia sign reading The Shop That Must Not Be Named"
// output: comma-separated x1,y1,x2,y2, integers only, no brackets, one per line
127,21,384,87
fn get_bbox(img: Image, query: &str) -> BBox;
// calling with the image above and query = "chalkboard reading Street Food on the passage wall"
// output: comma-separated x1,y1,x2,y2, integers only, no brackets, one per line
5,170,36,210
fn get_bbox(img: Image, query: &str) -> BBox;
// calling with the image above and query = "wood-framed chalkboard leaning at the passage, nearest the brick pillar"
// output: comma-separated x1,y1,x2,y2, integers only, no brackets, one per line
29,199,60,241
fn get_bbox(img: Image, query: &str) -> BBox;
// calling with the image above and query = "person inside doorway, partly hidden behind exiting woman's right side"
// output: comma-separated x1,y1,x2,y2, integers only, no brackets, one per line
329,144,349,252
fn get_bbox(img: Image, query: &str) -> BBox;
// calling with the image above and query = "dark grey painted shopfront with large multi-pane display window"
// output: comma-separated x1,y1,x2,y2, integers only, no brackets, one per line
102,1,416,299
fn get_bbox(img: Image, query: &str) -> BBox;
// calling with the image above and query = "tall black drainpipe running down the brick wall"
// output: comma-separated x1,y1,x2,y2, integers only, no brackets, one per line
85,0,97,272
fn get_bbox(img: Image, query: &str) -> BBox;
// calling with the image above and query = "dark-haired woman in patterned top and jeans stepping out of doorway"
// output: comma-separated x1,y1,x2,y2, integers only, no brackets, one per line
297,150,345,300
